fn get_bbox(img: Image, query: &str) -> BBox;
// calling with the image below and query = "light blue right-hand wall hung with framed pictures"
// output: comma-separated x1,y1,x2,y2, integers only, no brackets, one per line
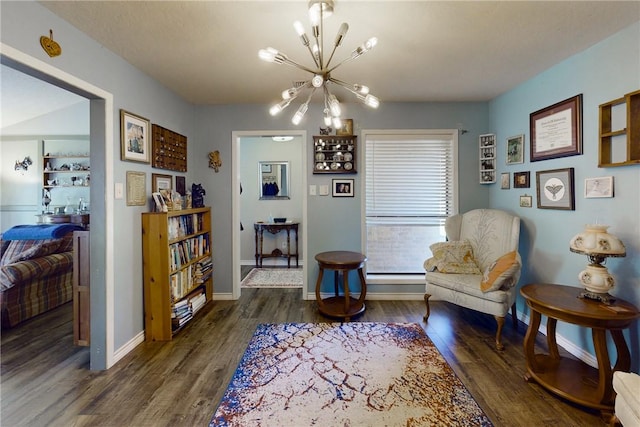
489,23,640,372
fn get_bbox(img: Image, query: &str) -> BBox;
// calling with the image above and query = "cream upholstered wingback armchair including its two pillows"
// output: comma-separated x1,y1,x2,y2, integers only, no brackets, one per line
424,209,522,350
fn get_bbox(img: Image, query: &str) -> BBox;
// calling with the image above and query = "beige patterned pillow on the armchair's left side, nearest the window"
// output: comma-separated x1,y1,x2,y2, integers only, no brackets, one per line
424,240,482,274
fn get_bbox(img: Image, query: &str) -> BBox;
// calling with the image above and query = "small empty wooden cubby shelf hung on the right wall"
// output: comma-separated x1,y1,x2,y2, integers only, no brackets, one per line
598,90,640,168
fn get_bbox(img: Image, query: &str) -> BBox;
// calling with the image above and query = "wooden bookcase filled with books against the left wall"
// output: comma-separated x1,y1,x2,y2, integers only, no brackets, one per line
142,207,213,341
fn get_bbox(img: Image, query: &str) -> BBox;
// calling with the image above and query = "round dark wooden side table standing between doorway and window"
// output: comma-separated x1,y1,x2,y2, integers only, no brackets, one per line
315,251,367,322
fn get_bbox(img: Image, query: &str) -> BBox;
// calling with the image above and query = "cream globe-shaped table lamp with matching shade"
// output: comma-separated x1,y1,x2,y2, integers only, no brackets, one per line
569,224,626,304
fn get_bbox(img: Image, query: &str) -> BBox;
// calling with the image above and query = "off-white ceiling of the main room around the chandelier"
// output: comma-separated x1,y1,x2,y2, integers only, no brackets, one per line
32,0,640,104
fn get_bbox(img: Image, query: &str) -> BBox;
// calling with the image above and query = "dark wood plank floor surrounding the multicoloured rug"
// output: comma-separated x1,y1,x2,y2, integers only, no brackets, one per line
0,289,604,427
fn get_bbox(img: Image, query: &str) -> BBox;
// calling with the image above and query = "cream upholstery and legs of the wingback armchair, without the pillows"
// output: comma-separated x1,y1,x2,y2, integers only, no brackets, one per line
425,209,522,349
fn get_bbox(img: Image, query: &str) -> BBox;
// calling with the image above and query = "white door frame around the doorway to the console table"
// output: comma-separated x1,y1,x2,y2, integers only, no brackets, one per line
231,130,309,300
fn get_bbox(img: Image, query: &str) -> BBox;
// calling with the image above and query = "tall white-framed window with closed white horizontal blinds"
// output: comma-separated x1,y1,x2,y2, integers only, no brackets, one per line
363,130,458,275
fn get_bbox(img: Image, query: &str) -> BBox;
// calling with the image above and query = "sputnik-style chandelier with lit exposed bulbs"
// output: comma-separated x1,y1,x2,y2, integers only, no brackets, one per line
258,0,380,129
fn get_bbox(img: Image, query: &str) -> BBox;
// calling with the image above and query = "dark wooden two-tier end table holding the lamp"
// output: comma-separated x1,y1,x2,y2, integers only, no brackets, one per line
520,284,640,421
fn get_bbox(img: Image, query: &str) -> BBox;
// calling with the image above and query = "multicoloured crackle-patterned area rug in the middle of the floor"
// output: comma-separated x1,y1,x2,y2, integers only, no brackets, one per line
210,322,492,427
